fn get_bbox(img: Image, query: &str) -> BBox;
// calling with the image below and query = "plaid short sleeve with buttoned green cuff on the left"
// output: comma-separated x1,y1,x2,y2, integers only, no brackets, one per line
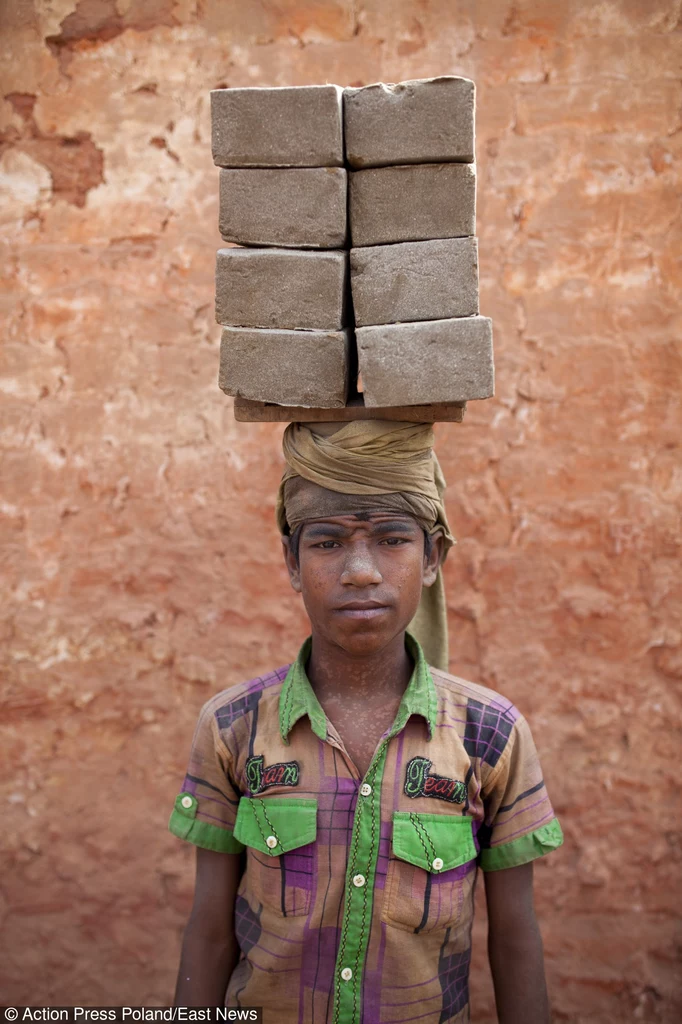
168,698,244,853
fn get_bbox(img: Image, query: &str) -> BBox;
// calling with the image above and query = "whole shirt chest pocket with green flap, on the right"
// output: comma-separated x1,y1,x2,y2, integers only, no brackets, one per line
382,811,476,933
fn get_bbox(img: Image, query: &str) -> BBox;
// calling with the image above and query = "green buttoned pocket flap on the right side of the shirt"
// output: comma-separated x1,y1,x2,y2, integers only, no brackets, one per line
392,811,476,873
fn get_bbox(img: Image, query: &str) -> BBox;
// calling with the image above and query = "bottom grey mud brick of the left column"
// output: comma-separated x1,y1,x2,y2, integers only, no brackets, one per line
218,327,350,409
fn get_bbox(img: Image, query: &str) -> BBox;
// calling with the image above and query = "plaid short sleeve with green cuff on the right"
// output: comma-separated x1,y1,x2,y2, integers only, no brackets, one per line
479,716,563,871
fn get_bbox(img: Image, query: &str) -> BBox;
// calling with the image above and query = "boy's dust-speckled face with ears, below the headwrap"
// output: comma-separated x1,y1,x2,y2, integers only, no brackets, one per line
284,503,442,656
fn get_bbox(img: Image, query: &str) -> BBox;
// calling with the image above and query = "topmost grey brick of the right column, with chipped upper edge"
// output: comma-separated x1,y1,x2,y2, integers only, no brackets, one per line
343,76,475,168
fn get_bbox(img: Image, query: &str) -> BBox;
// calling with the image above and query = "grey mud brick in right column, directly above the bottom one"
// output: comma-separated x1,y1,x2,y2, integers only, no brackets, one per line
350,238,478,327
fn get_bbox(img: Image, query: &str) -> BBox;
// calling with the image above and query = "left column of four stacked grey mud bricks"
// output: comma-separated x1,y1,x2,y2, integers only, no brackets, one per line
211,85,353,409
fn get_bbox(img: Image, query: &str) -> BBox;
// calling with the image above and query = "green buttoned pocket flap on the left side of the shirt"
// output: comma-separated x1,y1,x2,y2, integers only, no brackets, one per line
235,797,317,857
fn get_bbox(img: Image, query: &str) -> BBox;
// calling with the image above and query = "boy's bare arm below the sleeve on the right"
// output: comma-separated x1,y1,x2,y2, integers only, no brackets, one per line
485,862,550,1024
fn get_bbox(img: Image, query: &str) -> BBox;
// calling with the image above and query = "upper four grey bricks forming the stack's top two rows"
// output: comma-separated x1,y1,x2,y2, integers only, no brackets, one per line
211,77,475,249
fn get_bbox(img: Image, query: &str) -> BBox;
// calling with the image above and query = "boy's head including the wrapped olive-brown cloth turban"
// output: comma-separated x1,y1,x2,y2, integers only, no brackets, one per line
278,421,453,668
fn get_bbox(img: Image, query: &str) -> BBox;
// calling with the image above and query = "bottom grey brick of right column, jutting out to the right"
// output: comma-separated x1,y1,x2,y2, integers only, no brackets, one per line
356,316,495,407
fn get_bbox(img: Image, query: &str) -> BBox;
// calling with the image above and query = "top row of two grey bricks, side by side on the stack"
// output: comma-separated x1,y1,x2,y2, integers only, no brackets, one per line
211,76,474,170
